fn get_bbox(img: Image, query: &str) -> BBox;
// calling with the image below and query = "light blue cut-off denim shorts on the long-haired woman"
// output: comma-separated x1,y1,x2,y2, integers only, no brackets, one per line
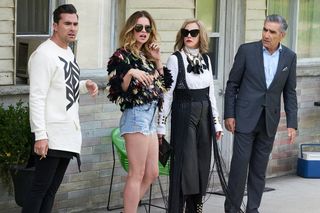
120,101,157,135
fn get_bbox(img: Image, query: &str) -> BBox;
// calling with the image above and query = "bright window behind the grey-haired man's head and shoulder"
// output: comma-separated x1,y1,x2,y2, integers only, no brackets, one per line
268,0,320,58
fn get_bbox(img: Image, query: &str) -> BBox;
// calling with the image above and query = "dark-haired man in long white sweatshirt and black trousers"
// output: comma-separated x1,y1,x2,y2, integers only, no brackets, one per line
22,4,98,213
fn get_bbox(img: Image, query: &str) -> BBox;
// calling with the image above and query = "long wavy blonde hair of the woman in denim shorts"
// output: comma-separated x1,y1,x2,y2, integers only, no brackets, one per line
119,10,158,61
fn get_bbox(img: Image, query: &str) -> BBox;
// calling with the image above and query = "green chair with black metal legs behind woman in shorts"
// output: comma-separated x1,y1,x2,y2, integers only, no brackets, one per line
107,128,170,212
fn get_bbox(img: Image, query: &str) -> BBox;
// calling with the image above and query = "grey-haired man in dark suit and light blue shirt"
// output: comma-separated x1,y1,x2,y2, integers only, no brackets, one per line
224,15,297,213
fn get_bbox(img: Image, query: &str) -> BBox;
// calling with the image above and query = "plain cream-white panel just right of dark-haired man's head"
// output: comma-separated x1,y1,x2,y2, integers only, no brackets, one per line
68,0,112,69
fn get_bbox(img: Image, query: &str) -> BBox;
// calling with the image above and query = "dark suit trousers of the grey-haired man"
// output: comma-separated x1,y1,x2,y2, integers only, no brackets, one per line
225,110,275,213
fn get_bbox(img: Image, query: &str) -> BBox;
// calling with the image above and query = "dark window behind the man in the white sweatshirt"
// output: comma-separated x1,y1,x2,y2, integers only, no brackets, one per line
16,0,64,84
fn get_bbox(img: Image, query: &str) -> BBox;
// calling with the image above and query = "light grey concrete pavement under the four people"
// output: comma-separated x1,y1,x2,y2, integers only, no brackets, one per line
93,175,320,213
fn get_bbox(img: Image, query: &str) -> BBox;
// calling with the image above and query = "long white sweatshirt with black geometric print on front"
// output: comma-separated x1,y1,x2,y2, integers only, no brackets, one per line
28,39,88,153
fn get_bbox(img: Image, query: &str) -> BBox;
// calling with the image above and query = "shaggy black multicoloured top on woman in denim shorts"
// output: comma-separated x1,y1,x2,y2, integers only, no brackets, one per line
107,48,172,111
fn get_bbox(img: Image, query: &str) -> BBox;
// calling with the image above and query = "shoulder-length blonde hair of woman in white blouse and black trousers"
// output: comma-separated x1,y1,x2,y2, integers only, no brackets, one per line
174,19,209,54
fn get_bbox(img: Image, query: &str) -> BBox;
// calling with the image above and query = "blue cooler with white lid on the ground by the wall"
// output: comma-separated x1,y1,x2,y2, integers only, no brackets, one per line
297,144,320,178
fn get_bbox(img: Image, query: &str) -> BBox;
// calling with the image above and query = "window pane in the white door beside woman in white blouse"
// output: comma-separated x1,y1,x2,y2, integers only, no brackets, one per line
196,0,221,78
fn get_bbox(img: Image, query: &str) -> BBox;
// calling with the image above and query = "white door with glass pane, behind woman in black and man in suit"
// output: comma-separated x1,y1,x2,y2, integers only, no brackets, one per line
196,0,243,171
